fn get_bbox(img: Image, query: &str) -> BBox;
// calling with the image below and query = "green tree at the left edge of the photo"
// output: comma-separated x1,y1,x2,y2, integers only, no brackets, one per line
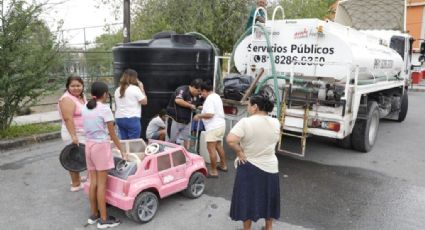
0,0,58,130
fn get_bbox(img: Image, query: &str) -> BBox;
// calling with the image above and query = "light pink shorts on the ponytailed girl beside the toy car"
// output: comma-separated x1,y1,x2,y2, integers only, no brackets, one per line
86,140,115,171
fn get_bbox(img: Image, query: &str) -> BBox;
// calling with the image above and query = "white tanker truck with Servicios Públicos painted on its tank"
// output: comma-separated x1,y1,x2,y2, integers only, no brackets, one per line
220,6,413,156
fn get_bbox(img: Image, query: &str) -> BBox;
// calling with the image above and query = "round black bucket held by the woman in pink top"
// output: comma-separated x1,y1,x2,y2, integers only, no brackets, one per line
59,143,87,172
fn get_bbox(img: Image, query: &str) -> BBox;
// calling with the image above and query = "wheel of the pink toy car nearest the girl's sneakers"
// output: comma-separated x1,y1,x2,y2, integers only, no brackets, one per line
127,192,159,223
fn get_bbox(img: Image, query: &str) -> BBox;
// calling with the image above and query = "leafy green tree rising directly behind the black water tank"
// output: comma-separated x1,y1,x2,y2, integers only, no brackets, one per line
98,0,255,52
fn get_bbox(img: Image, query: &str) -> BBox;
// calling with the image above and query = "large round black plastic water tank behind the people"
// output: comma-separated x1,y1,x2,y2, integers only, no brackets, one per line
112,32,214,138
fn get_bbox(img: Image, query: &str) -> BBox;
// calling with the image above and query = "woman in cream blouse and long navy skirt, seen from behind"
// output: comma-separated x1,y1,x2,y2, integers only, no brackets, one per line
227,95,280,230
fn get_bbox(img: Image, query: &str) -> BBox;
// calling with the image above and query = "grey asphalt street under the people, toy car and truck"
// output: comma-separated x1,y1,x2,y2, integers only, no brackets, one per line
0,92,425,230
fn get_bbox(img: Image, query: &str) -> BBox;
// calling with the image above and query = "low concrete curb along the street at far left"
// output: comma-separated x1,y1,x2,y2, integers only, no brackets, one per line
0,131,61,151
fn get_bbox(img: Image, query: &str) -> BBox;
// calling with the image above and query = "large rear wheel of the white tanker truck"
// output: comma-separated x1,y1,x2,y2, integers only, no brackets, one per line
351,101,380,153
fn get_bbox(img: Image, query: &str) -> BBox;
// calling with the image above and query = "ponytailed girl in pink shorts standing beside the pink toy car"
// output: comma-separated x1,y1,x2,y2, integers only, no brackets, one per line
82,82,125,229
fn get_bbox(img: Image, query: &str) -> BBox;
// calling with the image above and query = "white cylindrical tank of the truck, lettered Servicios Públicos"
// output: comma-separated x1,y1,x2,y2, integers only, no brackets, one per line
234,19,405,82
